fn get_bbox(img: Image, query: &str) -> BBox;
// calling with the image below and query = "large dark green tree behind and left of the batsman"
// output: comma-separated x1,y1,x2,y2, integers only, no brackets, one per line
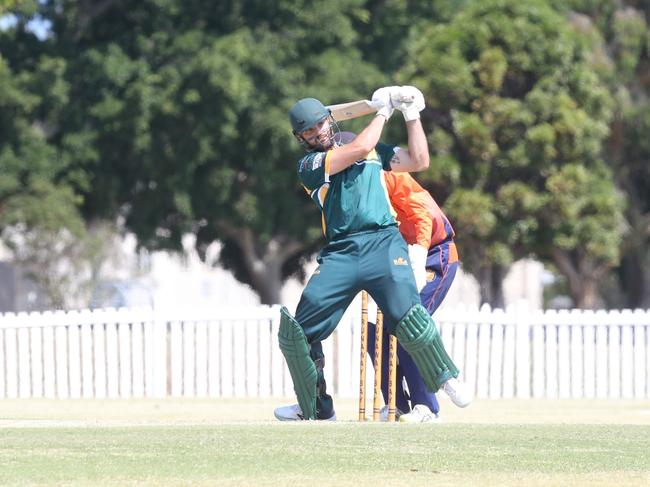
24,0,383,303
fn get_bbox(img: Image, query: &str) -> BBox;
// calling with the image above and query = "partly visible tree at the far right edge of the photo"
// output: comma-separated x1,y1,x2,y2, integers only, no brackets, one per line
558,0,650,308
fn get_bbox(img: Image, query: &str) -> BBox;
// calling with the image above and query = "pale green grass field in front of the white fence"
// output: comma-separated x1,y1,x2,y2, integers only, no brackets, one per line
0,399,650,487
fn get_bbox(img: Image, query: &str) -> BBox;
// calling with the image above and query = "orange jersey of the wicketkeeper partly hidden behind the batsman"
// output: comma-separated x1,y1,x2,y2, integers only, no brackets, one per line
384,171,454,249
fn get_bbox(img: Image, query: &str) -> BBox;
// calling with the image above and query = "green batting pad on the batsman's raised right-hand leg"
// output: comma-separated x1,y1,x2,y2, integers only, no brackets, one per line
395,304,458,392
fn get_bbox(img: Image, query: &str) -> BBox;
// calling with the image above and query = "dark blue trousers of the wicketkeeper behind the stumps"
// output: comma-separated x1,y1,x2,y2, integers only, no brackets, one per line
368,242,458,414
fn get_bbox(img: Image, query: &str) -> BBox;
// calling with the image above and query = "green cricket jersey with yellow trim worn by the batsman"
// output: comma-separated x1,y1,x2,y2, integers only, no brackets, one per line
298,143,397,240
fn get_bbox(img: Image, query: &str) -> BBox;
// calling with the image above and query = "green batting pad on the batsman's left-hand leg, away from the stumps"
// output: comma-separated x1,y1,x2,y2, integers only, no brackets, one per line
278,306,318,419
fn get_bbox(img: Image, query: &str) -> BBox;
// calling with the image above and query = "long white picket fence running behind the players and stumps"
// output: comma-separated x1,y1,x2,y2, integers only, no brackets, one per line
0,301,650,398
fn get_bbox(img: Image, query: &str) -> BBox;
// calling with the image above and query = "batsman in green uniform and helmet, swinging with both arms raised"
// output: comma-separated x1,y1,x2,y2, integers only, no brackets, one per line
276,87,472,419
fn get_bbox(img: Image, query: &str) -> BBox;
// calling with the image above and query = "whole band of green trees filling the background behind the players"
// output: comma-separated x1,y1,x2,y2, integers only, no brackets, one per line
0,0,650,307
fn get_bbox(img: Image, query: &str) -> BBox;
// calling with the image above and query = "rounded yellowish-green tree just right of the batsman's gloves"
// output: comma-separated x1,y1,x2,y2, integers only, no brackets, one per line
400,0,621,306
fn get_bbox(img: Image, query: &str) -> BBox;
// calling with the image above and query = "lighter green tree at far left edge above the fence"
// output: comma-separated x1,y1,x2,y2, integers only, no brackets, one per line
0,34,92,308
